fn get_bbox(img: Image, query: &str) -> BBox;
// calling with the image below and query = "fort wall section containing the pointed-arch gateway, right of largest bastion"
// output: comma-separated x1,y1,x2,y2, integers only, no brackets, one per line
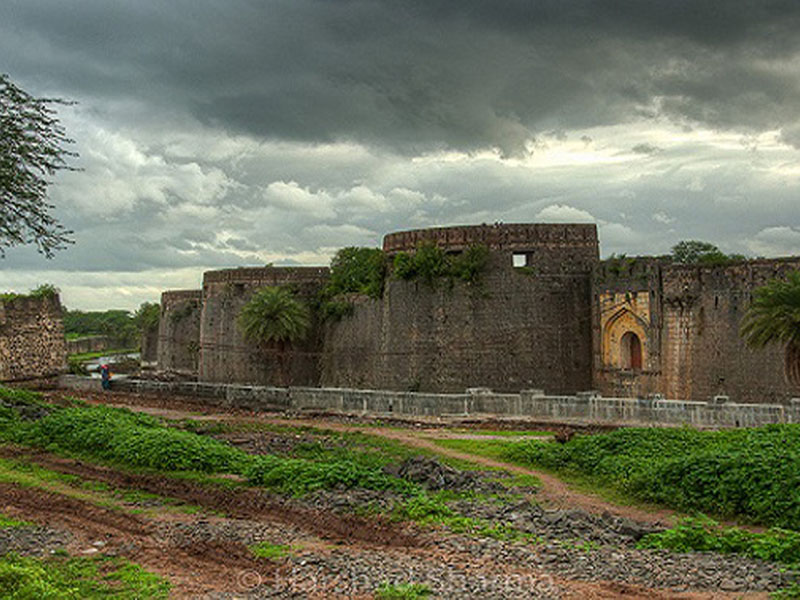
593,258,800,403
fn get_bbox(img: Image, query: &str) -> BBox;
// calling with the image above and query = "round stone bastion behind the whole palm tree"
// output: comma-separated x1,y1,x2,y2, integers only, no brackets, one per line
199,267,329,385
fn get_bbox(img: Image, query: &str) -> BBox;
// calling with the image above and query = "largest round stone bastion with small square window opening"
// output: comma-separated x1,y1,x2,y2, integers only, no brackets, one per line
322,224,599,393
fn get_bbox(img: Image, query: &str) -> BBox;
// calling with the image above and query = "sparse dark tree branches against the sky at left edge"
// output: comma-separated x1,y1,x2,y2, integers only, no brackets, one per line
0,74,76,258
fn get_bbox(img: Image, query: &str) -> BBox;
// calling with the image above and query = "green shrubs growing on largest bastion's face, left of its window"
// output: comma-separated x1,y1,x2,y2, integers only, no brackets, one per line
393,242,489,286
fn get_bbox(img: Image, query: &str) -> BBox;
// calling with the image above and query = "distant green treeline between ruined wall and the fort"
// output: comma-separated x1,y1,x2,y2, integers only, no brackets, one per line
64,302,160,348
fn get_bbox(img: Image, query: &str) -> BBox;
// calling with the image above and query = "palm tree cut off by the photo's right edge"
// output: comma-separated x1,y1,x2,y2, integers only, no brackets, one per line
739,271,800,384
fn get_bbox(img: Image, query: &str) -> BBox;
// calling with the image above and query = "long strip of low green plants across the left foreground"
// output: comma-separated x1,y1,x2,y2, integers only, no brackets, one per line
0,390,415,495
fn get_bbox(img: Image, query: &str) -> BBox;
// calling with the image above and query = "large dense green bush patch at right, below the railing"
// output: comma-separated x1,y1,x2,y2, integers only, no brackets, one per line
505,425,800,529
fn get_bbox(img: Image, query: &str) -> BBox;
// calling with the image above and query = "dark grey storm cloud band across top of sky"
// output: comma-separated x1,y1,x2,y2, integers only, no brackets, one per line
0,0,800,153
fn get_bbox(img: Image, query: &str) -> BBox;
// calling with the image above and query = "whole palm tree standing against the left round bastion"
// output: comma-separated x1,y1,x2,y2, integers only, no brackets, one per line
237,287,311,385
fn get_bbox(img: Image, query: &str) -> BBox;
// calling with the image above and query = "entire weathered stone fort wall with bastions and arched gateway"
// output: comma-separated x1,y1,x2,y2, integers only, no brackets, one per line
159,224,800,403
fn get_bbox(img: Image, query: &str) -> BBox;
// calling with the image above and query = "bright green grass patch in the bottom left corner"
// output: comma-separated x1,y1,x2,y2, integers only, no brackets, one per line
0,554,170,600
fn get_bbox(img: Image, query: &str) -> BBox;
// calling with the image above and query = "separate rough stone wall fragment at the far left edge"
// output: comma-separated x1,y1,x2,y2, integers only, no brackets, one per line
0,296,67,382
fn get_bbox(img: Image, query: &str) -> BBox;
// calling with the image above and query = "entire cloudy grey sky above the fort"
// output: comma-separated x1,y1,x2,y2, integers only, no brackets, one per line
0,0,800,309
